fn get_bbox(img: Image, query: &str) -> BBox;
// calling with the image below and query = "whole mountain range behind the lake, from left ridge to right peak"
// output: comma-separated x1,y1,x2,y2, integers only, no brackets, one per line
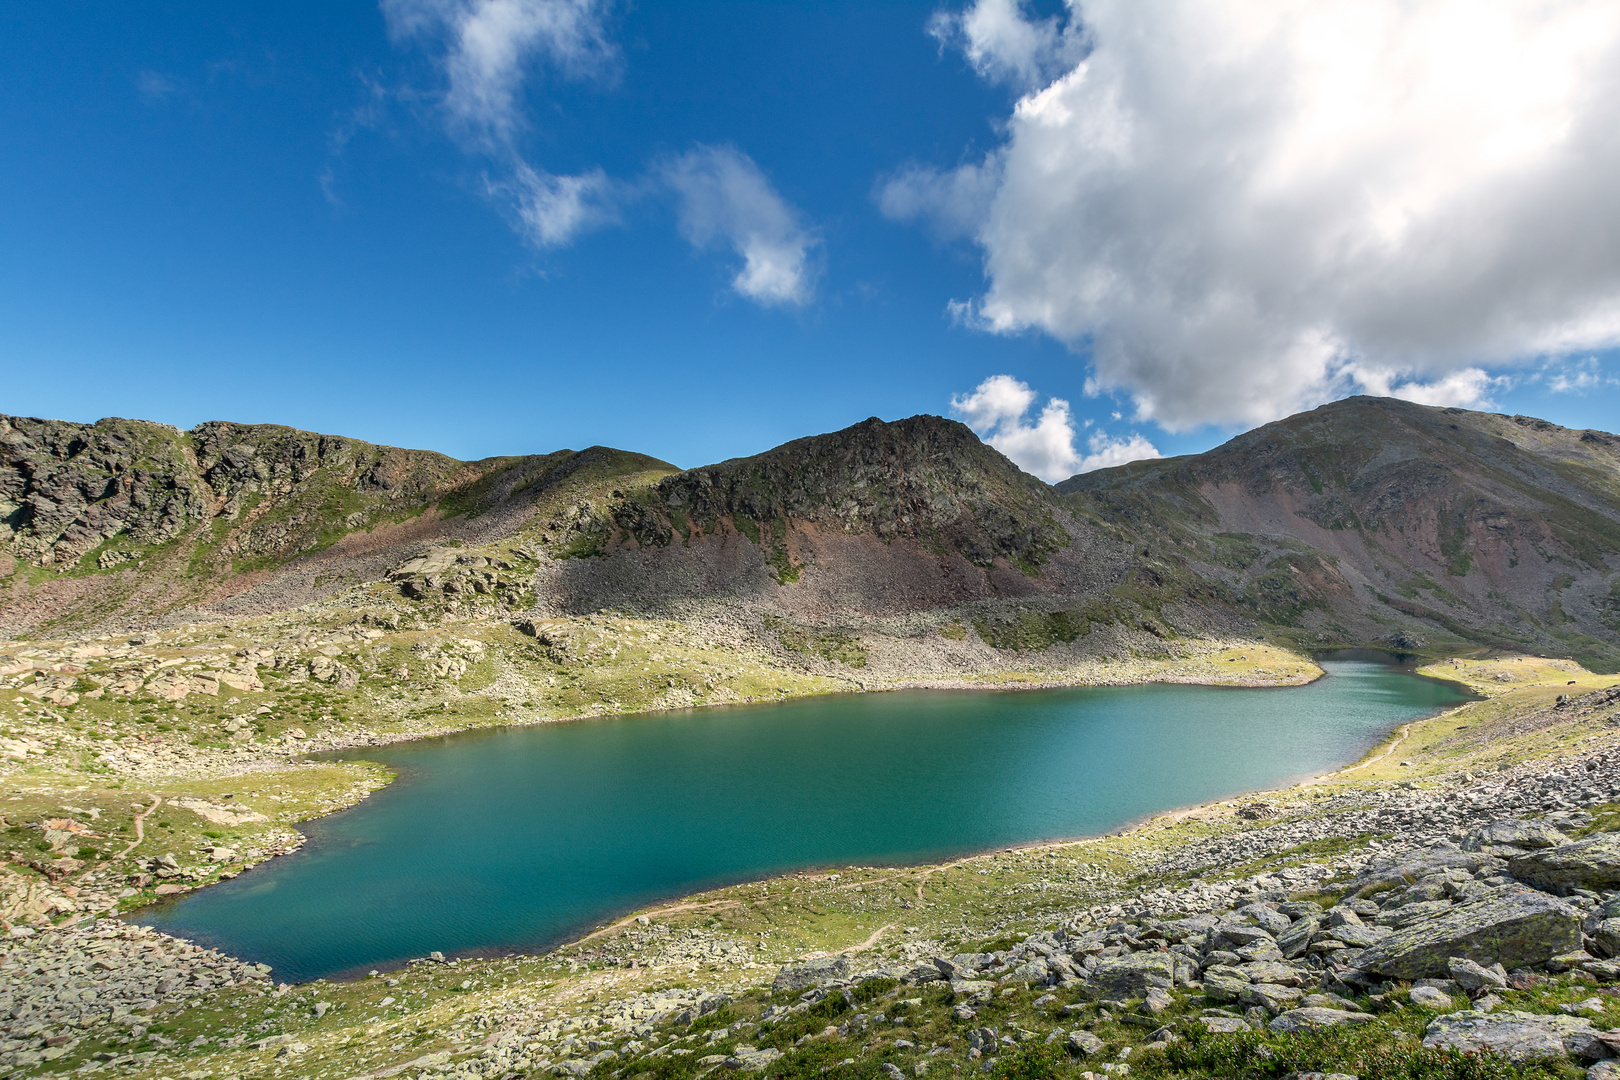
0,398,1620,670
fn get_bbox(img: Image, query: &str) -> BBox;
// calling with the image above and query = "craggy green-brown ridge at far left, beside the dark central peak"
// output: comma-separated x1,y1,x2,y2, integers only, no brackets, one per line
0,416,674,633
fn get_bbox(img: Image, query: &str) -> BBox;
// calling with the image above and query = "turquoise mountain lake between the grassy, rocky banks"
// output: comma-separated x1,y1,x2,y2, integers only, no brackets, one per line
141,661,1463,981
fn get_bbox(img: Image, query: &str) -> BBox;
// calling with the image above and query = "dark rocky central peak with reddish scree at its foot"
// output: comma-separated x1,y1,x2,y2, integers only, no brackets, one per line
515,416,1126,622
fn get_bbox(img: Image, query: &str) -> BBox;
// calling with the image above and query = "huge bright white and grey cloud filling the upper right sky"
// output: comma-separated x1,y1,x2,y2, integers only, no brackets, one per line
878,0,1620,431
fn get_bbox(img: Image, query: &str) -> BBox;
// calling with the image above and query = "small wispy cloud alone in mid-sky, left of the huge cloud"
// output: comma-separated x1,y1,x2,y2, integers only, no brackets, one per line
658,146,816,304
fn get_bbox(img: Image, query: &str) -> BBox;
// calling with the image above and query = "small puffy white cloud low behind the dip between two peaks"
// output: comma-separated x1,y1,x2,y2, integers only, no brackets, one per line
951,376,1162,484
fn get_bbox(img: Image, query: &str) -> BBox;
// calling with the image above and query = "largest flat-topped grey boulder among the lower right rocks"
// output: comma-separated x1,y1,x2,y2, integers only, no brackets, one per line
1354,891,1581,978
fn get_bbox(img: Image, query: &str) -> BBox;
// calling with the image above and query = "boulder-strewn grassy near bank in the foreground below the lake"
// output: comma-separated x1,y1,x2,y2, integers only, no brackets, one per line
0,676,1620,1080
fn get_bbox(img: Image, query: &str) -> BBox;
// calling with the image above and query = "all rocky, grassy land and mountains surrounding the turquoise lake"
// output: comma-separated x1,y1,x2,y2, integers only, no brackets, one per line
9,398,1620,1080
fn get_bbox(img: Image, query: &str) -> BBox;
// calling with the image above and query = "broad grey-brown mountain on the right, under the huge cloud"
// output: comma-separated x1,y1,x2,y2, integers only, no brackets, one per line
1058,397,1620,669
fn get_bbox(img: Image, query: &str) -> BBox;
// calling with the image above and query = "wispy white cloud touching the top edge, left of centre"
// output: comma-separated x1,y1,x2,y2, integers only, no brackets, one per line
382,0,617,144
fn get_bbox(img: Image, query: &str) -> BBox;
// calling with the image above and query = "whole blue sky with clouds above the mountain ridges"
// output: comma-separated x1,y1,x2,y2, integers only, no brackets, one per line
0,0,1620,476
